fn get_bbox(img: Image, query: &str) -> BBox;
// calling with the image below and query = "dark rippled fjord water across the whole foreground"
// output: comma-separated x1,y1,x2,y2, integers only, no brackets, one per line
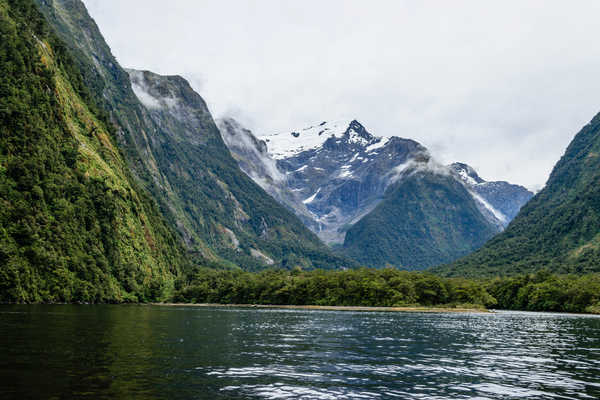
0,305,600,399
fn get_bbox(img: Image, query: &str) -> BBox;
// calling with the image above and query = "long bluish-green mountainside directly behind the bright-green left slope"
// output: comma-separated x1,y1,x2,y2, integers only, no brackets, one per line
37,0,346,269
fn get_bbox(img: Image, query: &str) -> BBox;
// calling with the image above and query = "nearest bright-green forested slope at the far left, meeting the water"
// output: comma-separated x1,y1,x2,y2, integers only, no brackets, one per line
0,0,187,302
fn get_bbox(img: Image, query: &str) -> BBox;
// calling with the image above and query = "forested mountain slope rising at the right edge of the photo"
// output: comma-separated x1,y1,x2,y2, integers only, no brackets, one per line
437,114,600,276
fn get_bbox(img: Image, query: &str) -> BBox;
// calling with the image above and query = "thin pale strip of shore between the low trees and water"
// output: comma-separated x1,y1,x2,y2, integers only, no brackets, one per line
150,303,493,313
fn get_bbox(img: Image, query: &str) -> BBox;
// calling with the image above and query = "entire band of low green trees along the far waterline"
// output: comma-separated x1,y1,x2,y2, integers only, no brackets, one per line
174,268,600,313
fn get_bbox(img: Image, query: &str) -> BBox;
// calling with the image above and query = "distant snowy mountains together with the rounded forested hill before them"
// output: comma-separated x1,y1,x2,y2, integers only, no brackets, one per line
220,120,533,268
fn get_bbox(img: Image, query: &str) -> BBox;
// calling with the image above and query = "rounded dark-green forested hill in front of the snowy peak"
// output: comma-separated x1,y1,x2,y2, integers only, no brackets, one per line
344,172,498,269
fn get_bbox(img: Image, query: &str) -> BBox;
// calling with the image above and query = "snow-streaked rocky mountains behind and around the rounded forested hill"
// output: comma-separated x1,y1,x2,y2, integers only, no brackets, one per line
220,120,527,244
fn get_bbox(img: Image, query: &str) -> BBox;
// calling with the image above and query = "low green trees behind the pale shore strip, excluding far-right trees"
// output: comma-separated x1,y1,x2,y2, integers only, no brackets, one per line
174,268,495,307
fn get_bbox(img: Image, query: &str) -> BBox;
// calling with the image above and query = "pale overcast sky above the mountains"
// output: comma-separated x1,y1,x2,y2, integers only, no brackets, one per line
84,0,600,188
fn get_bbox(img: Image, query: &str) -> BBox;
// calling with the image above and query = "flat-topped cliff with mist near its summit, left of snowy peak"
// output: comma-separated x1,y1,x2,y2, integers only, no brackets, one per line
128,70,356,269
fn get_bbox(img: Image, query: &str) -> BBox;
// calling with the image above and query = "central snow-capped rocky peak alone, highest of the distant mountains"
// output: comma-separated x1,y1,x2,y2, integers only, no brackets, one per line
253,119,427,243
